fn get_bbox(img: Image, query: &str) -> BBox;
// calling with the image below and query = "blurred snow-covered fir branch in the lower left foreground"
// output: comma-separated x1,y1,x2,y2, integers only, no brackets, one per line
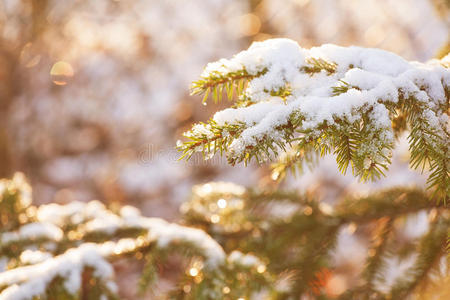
0,174,273,300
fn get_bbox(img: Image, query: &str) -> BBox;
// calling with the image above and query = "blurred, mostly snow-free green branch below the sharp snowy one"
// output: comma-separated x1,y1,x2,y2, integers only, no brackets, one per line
182,183,445,299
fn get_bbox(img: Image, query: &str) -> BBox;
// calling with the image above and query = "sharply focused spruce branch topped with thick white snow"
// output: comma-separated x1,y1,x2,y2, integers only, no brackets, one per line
178,39,450,197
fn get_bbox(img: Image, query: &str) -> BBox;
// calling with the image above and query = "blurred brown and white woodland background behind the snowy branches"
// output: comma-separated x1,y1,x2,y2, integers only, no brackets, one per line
0,0,450,298
